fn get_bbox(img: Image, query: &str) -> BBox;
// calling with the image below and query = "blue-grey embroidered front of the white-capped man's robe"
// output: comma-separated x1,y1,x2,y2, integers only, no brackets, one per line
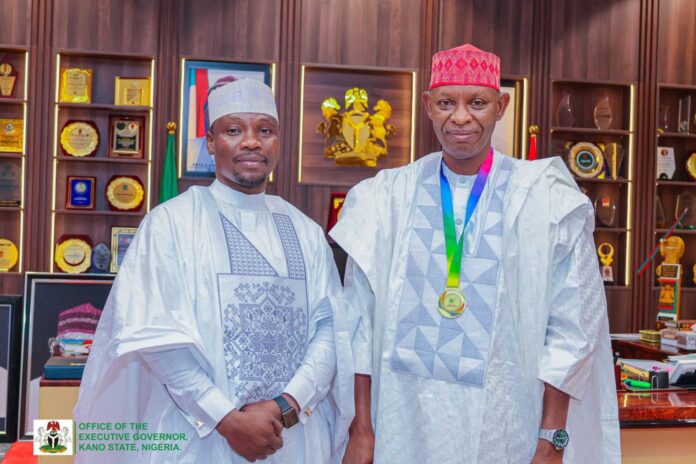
218,214,308,404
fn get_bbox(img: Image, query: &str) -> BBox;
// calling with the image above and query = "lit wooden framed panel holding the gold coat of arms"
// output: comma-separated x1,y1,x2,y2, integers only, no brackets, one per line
298,64,416,188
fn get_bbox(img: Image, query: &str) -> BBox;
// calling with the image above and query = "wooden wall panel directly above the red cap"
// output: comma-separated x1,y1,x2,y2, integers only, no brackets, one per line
438,0,534,76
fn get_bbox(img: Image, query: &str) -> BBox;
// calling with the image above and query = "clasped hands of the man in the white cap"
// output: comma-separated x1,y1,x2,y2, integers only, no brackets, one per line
216,406,283,462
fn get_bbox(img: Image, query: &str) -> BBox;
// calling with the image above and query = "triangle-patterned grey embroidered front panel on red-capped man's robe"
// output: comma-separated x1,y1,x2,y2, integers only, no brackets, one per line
390,158,512,387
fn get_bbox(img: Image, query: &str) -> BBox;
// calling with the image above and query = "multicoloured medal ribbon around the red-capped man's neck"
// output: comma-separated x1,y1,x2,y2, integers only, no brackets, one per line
440,148,493,289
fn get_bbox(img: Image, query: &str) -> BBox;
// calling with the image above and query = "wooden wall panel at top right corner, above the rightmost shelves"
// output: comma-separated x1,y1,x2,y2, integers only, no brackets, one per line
657,0,696,85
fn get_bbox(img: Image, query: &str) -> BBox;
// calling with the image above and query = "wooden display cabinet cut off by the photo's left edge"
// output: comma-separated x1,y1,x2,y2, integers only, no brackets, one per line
0,47,29,276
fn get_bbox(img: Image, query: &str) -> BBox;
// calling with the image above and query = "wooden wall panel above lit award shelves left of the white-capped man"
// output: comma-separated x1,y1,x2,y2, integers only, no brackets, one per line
53,0,161,55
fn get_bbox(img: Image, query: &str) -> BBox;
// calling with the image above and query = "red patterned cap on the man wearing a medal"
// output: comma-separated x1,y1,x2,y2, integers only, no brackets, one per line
430,44,500,90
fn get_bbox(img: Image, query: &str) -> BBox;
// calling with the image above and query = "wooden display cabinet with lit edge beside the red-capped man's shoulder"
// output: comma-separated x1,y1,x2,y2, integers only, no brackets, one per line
548,80,635,292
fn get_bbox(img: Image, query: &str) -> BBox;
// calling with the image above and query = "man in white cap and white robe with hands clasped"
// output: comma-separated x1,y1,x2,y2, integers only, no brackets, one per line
74,79,355,464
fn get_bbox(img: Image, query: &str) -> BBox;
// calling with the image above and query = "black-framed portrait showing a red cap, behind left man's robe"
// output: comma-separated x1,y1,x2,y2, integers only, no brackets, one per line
18,272,114,439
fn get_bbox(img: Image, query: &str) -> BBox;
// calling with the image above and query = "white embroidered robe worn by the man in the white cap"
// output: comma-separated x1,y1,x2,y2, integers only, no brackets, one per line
74,181,357,464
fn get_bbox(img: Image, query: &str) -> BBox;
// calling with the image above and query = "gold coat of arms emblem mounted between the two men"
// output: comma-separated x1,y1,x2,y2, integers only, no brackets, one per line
317,87,396,168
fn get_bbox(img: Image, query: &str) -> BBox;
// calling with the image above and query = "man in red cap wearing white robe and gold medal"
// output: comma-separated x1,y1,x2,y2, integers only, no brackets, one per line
331,45,620,464
